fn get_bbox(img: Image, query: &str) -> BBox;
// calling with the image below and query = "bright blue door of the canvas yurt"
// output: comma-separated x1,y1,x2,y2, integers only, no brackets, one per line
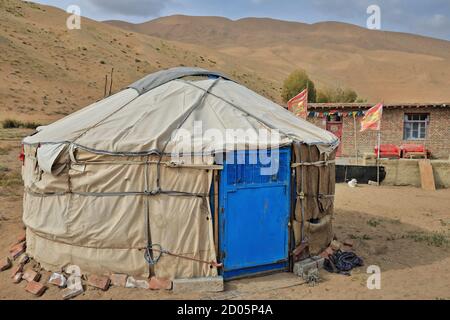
219,148,291,279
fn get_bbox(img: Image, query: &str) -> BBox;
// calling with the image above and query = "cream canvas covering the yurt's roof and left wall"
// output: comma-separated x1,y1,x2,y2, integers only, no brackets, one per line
22,68,338,279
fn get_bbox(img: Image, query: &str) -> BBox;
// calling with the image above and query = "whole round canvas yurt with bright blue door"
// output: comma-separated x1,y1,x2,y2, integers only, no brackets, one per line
22,68,339,279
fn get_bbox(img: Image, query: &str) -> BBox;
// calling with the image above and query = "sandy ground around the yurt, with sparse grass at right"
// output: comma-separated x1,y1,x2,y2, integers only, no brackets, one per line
0,129,450,299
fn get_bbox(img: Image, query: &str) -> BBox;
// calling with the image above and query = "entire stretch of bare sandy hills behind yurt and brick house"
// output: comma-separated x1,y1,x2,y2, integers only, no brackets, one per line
0,0,450,123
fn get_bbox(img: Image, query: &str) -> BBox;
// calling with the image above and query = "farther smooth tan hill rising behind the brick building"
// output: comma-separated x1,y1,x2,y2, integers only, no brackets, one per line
107,15,450,102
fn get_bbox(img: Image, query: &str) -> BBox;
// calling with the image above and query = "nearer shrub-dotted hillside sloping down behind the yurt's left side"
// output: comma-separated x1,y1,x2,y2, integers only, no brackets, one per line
0,0,279,123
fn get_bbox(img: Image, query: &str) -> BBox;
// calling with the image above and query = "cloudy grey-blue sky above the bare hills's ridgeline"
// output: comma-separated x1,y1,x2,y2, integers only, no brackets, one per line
30,0,450,40
